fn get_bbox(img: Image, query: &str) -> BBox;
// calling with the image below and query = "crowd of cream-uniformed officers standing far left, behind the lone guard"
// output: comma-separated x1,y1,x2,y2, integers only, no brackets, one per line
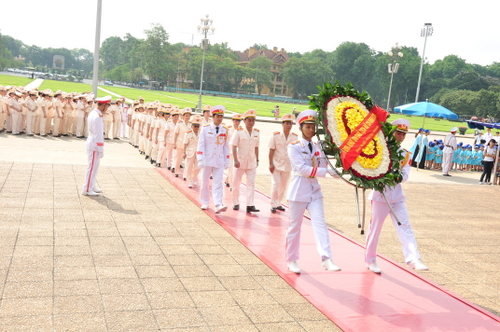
0,86,128,139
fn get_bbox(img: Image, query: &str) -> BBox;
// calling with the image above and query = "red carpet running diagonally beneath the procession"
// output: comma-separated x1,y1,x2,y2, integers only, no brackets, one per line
158,169,500,332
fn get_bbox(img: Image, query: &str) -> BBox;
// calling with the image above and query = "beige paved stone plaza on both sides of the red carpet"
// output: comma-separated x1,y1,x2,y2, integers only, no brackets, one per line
0,122,500,331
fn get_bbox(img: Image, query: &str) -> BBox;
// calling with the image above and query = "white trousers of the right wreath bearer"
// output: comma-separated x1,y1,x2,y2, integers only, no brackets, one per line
365,200,420,264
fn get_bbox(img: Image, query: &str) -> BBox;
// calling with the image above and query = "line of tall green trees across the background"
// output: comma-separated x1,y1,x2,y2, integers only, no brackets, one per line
0,24,500,118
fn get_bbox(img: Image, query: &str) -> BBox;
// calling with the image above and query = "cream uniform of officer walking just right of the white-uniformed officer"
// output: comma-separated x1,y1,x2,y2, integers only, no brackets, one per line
231,126,260,207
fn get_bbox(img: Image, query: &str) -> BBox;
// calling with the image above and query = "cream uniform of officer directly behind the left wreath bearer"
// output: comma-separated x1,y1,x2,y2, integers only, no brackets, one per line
269,131,299,208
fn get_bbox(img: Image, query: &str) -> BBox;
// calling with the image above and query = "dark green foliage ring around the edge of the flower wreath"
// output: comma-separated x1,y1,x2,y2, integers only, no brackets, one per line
309,82,404,192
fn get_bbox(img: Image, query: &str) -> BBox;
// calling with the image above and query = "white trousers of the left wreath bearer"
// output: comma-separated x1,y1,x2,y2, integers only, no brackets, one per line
286,198,332,262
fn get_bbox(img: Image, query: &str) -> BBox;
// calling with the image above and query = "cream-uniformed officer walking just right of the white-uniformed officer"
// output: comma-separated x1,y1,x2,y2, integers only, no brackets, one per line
231,109,260,213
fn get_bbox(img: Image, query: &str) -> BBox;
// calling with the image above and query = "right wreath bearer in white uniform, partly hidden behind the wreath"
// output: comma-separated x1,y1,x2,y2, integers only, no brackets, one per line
365,119,428,273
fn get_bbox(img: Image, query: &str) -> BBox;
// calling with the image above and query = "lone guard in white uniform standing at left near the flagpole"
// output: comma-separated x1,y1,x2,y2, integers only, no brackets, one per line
82,96,111,196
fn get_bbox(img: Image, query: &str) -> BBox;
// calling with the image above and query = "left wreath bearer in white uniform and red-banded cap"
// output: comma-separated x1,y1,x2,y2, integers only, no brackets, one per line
286,110,340,273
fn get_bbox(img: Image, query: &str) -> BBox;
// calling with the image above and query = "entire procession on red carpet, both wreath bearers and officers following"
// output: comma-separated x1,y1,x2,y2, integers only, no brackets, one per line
125,103,428,273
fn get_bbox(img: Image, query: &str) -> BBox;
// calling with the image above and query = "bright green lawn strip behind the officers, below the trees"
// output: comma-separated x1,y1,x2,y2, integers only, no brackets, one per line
0,75,466,133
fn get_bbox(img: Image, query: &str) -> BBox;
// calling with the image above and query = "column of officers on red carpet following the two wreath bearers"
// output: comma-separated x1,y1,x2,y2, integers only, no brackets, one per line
129,101,298,213
